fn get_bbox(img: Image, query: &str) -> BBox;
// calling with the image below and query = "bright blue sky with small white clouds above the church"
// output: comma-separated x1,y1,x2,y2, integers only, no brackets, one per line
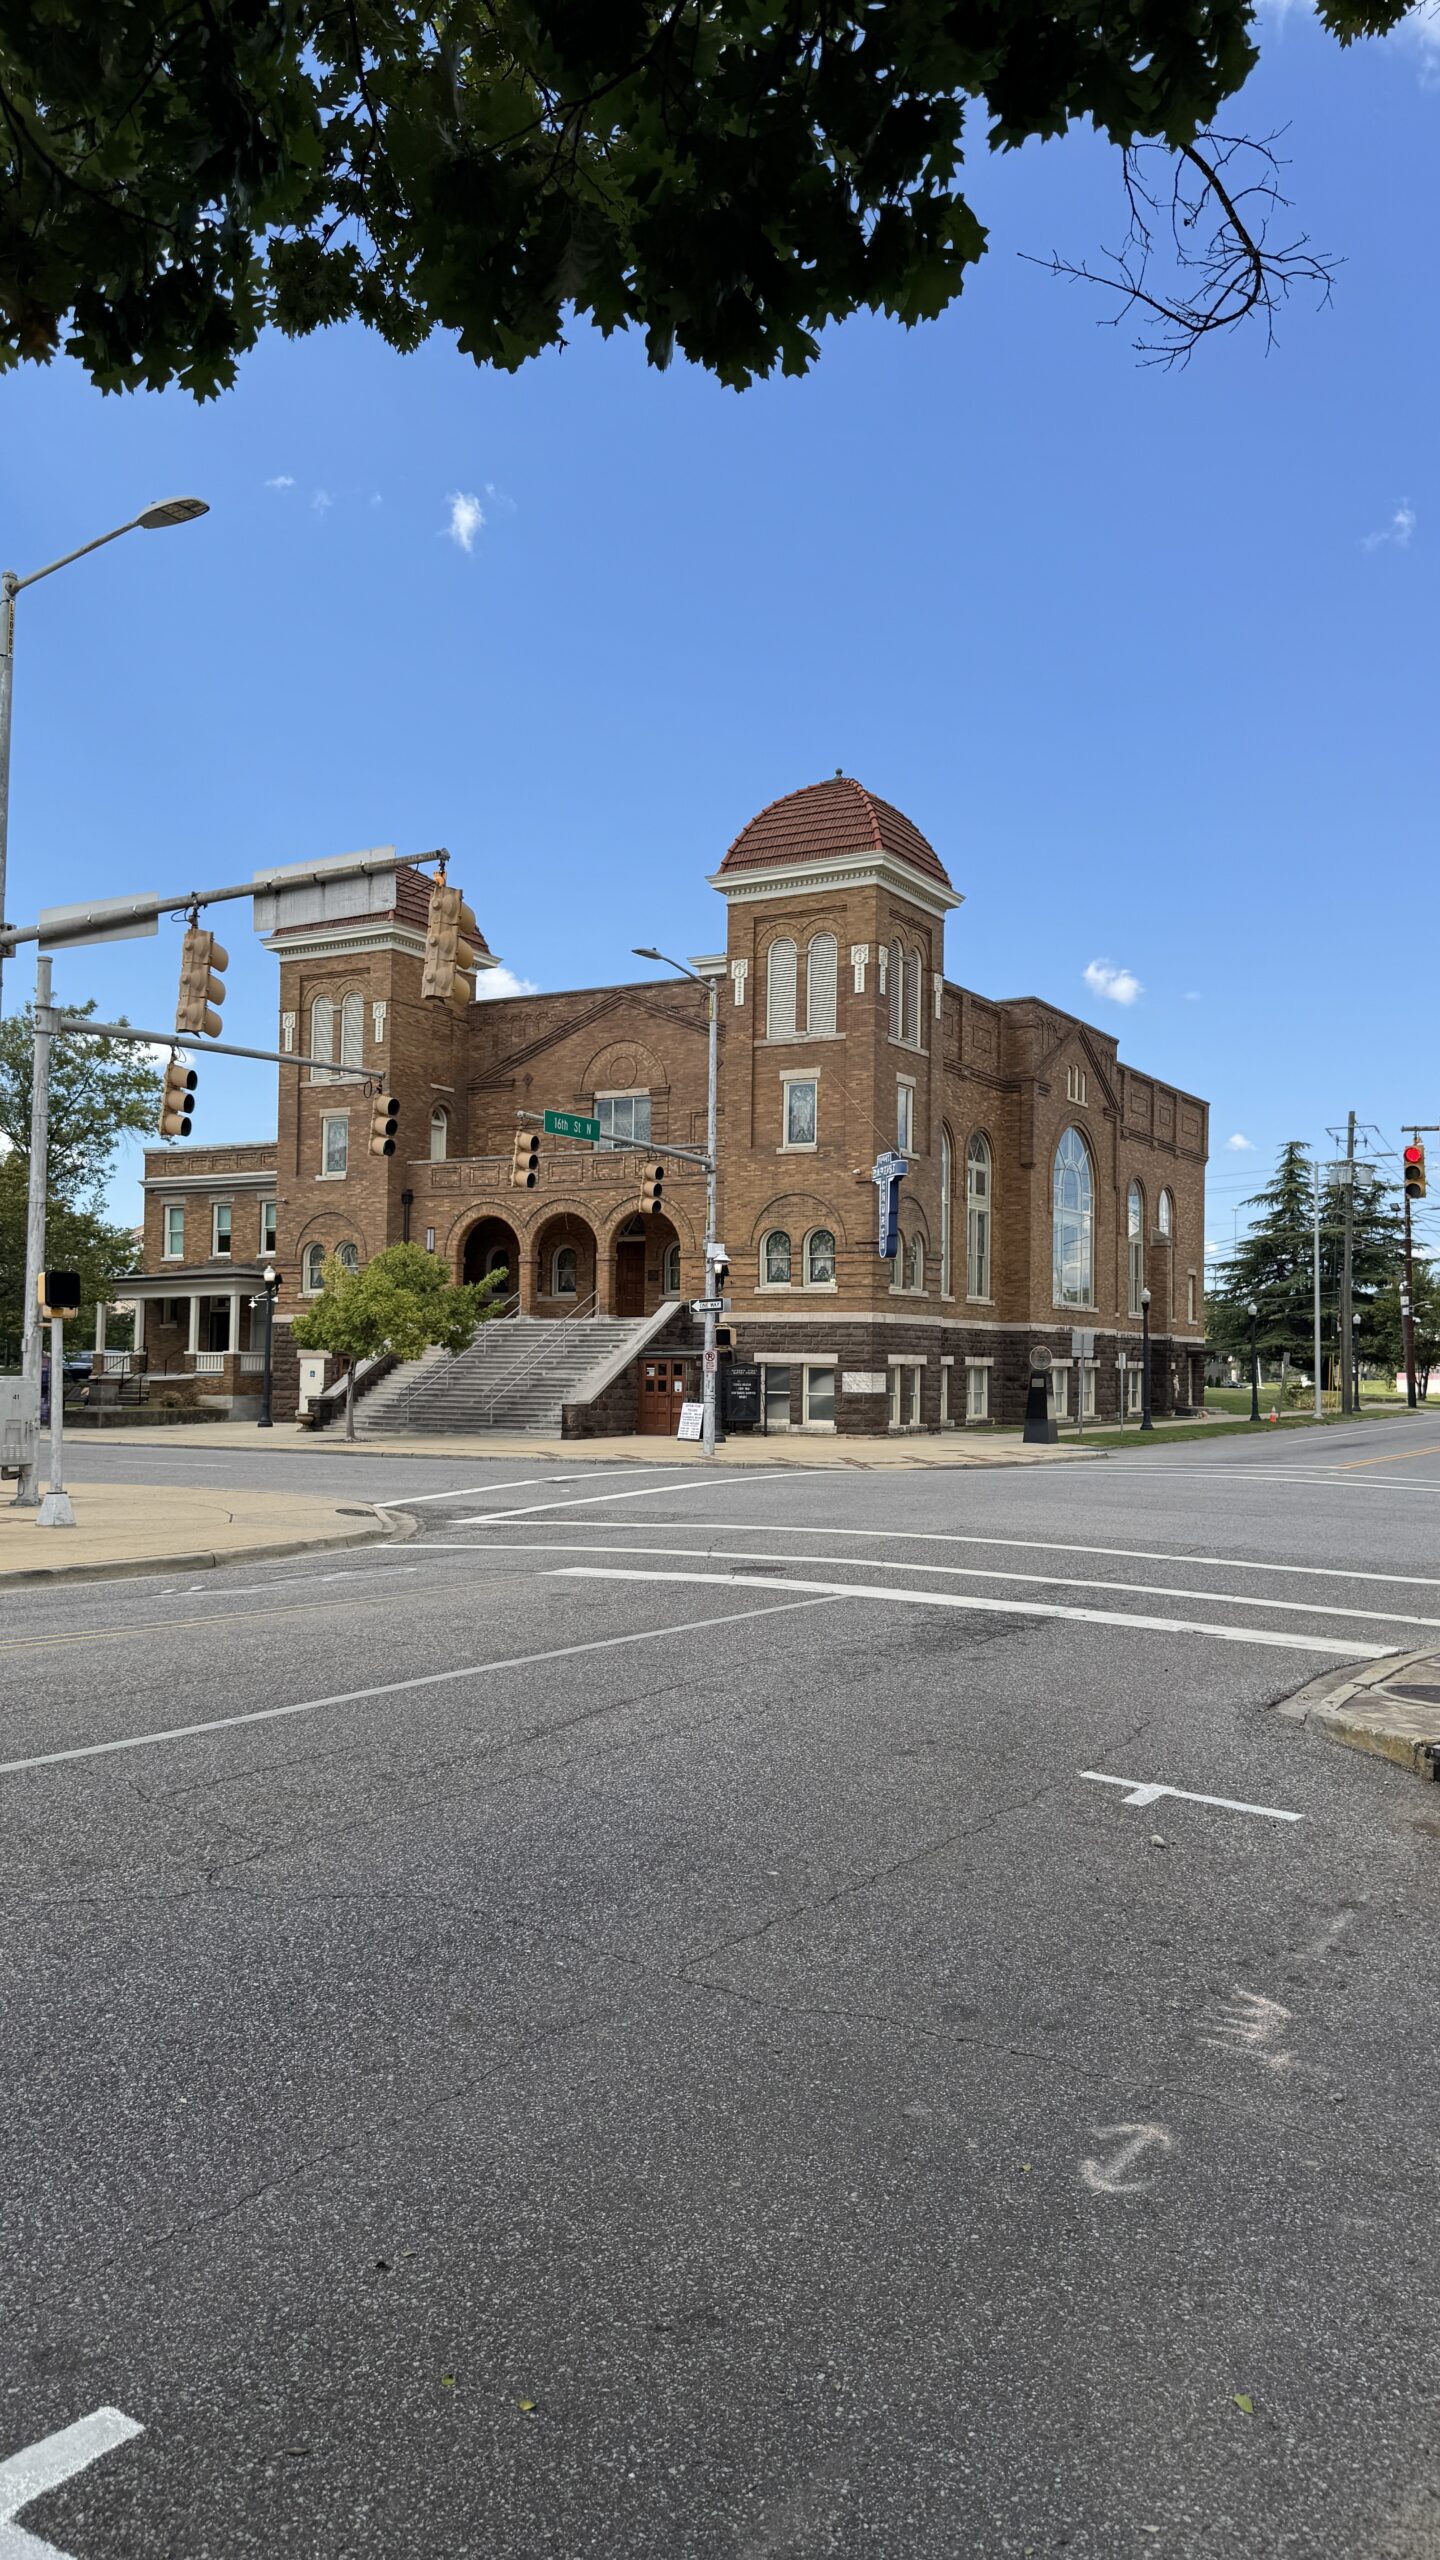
0,8,1440,1259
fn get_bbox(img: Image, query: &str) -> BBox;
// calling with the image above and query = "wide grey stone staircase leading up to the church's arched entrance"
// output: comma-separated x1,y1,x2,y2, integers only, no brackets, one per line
356,1300,676,1439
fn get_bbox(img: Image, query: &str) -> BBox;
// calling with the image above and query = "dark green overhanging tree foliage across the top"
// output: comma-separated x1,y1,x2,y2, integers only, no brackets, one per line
0,0,1409,397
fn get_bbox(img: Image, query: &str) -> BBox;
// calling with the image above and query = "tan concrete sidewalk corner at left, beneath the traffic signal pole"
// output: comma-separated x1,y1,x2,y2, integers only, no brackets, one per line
0,1482,397,1590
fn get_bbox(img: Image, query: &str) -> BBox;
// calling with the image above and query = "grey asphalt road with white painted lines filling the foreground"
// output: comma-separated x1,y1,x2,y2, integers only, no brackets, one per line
0,1418,1440,2560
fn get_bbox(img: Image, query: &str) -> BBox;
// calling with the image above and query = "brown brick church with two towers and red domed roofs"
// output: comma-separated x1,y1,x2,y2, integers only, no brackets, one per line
110,773,1207,1434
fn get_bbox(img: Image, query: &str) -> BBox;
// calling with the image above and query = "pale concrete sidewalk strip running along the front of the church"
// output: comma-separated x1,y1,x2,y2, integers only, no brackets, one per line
67,1423,1086,1467
